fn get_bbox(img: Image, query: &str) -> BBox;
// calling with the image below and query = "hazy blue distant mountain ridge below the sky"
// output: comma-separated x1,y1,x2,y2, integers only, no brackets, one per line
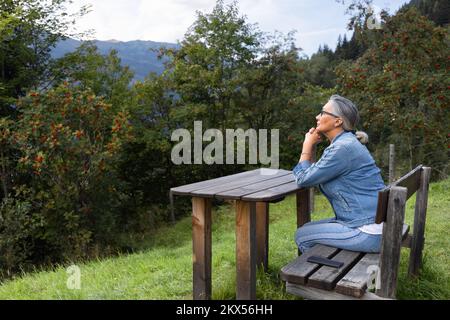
52,39,179,80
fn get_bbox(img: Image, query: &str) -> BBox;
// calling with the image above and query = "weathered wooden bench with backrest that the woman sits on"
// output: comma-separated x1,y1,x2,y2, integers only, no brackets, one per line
281,165,431,299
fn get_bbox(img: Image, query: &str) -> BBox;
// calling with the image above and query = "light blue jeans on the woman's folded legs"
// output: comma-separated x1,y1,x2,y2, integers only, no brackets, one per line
295,218,381,253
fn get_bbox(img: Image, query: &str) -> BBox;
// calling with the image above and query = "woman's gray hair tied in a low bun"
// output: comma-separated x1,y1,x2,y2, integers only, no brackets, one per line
329,94,369,144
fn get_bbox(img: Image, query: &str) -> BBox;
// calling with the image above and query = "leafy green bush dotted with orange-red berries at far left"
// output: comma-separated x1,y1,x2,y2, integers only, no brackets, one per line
7,85,131,261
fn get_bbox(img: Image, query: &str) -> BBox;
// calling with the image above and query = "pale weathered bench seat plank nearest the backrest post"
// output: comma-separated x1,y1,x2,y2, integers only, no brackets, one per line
335,253,380,298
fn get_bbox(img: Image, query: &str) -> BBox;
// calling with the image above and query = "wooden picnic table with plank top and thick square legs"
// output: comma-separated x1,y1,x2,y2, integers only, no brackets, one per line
170,168,310,299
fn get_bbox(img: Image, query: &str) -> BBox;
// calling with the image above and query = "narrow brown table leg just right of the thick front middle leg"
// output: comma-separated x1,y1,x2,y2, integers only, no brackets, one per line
256,202,269,272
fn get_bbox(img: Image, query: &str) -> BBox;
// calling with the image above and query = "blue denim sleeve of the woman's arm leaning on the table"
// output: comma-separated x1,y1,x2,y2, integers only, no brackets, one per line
292,144,349,187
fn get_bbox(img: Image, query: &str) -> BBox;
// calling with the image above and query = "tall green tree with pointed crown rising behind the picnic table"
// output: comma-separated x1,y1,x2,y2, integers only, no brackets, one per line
158,1,323,175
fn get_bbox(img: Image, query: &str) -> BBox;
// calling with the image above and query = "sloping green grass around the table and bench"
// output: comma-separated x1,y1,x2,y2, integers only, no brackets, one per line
0,179,450,299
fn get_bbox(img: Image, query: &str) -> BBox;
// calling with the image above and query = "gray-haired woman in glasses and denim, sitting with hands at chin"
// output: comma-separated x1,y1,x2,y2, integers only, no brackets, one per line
293,95,385,252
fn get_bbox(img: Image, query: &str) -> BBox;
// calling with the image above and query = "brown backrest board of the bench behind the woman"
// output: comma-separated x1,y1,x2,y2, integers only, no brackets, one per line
375,165,423,223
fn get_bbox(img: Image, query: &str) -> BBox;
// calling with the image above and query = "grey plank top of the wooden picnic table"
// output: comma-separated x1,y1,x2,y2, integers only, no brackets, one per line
170,168,301,201
